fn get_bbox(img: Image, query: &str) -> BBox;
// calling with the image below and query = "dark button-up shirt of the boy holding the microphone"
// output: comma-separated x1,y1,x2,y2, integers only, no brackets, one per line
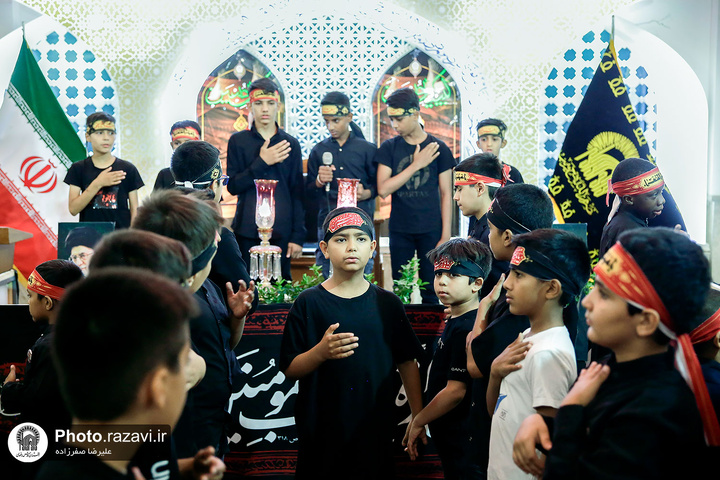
306,133,377,226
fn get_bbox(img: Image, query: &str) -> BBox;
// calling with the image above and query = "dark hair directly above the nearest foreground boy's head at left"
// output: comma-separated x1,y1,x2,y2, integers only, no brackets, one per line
90,229,192,284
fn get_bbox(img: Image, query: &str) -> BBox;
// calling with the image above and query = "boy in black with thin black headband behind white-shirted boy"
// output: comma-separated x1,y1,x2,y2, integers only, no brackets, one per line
467,183,556,478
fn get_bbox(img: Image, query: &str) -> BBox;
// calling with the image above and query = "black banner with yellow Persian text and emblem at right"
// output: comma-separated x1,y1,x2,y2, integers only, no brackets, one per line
548,40,685,264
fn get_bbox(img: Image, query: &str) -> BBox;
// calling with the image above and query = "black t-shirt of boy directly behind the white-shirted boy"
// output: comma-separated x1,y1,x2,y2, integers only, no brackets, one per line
470,288,530,466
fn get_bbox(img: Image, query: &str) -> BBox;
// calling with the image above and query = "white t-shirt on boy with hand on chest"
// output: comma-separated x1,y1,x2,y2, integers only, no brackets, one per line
488,326,577,480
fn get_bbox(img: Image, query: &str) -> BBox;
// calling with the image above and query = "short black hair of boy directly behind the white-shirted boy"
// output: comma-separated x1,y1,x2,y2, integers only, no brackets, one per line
495,183,555,231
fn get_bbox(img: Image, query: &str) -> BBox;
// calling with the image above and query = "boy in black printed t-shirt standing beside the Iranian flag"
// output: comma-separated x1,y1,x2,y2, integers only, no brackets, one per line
64,112,144,229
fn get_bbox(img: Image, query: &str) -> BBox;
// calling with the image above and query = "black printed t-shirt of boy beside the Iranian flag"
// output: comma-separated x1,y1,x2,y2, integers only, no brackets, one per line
64,157,145,229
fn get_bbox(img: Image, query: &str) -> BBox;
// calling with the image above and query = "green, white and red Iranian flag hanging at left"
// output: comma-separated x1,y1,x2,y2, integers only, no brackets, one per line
0,38,85,284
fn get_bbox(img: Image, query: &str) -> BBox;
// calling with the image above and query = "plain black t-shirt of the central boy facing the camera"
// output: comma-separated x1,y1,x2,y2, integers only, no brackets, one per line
279,284,423,479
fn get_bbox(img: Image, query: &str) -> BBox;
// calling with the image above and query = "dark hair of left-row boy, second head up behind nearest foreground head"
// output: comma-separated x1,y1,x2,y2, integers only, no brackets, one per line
132,190,223,258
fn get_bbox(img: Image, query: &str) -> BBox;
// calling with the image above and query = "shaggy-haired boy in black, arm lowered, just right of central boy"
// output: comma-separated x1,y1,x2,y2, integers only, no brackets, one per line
403,238,492,480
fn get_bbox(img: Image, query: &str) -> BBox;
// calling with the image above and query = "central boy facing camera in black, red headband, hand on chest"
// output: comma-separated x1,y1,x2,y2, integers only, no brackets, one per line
279,207,422,480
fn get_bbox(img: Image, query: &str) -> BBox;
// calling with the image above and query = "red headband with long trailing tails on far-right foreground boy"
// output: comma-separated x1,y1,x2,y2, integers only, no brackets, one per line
594,242,720,446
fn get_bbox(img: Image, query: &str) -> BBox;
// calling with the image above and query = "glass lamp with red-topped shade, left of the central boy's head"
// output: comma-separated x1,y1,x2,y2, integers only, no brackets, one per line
249,180,282,288
